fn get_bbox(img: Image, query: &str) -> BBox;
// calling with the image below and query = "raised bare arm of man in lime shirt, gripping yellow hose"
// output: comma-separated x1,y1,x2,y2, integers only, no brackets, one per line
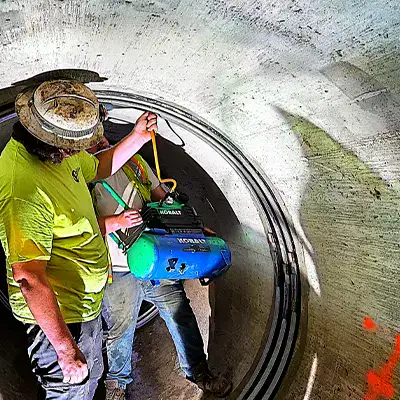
94,112,157,180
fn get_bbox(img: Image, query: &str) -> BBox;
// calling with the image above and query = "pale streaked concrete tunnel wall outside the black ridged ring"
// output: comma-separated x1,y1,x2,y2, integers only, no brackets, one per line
0,0,400,400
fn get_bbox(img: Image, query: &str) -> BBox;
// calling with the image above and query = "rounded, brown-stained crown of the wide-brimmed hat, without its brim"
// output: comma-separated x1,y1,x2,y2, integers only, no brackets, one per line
32,80,99,133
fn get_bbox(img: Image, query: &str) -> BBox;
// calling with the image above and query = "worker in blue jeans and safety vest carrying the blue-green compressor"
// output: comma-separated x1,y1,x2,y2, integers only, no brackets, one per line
89,138,232,400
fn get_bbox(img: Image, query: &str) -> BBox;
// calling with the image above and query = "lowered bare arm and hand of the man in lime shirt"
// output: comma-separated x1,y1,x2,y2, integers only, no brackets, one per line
12,260,88,383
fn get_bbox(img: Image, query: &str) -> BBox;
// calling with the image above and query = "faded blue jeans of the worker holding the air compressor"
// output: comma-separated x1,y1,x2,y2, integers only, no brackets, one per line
103,272,206,388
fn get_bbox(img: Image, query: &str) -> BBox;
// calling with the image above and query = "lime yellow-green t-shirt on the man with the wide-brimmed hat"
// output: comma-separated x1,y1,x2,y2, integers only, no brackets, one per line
0,139,108,323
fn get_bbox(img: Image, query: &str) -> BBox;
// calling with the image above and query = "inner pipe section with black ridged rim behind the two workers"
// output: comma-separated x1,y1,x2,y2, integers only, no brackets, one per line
0,91,300,399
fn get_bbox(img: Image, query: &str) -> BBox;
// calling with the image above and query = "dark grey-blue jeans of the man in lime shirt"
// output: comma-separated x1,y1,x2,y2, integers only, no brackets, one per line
25,316,103,400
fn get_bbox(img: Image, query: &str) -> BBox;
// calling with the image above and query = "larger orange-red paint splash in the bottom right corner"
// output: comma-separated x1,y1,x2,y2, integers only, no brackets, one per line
364,335,400,400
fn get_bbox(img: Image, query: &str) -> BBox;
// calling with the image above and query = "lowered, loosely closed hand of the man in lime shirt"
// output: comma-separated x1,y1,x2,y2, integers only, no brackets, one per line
57,346,89,384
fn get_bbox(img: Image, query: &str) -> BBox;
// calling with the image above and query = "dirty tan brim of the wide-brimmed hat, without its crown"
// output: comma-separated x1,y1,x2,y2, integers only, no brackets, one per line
15,87,104,150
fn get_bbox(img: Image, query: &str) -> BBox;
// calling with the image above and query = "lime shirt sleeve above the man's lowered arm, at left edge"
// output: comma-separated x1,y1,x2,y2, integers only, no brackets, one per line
0,198,54,264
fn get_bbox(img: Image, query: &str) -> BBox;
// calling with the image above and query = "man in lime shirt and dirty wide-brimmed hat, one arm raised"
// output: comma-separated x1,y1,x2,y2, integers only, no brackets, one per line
0,80,157,400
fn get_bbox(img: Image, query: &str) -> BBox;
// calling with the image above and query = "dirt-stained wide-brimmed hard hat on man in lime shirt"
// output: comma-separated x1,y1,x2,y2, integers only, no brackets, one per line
15,80,104,150
